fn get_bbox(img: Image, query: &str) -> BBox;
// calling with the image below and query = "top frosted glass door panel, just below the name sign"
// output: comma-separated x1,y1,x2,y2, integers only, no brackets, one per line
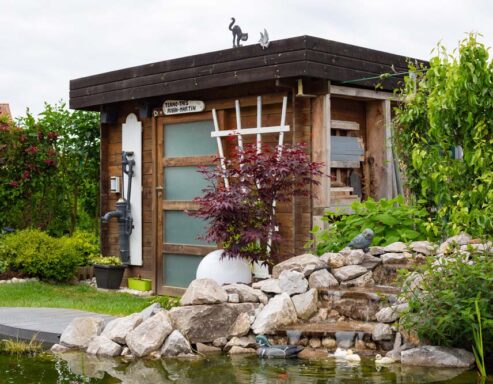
164,121,217,157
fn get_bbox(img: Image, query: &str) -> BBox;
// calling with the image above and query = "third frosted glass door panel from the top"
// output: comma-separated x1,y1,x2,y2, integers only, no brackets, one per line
164,211,207,245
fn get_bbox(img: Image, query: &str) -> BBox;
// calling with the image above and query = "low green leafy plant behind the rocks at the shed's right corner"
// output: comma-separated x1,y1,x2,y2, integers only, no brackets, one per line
312,196,437,255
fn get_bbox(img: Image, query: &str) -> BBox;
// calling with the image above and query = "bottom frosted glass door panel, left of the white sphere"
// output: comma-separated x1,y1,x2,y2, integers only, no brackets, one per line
164,254,202,288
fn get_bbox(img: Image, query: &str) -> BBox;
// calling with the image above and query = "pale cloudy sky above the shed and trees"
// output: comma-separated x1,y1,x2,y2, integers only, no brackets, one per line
0,0,493,116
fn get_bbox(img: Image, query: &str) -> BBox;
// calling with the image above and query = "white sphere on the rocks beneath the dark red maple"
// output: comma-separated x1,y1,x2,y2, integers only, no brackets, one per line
197,249,252,285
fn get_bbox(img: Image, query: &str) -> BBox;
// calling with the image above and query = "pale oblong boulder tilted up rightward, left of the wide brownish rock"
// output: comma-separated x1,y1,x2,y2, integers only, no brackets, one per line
126,311,173,357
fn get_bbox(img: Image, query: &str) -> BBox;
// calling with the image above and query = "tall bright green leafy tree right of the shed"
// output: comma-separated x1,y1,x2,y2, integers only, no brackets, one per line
393,34,493,237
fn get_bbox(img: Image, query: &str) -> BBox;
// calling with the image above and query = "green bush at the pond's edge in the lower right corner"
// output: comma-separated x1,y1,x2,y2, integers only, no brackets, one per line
400,251,493,355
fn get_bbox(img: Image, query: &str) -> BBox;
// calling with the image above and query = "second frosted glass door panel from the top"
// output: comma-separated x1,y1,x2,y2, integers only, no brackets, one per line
164,166,209,200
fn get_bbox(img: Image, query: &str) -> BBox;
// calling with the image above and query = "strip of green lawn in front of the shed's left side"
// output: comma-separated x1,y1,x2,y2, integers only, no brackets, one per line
0,282,176,316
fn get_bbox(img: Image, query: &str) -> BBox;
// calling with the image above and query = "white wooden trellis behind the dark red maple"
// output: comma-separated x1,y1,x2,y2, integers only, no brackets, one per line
211,96,289,272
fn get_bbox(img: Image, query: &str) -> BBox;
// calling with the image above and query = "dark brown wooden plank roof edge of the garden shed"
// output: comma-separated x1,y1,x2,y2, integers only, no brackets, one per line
70,36,422,110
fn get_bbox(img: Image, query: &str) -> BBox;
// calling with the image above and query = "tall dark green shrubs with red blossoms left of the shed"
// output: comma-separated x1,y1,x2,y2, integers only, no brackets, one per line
0,103,99,236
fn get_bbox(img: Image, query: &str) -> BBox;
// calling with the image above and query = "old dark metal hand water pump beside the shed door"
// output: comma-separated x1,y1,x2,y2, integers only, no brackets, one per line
101,151,135,265
